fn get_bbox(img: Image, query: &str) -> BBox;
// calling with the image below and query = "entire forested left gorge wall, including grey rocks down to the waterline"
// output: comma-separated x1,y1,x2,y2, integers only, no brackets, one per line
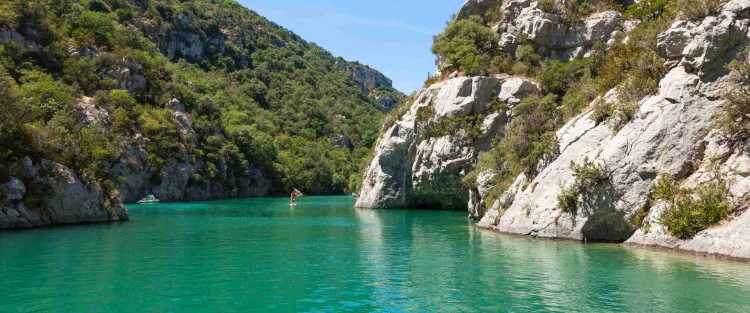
0,0,404,229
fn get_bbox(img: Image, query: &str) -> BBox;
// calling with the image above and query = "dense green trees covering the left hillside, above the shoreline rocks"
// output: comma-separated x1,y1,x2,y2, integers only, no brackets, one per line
0,0,402,193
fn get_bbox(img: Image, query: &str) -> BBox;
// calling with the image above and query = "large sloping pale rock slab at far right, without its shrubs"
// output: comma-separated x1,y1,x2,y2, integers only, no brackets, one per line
472,1,750,258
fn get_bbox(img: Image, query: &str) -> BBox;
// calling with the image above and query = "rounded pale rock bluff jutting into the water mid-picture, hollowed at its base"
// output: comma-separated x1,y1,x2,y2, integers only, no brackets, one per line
356,77,536,210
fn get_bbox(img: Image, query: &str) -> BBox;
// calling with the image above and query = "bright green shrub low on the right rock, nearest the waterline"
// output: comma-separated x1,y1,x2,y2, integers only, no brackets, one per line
653,176,731,239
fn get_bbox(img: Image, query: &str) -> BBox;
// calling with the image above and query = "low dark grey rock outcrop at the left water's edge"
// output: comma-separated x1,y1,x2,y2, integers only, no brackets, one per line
0,157,128,229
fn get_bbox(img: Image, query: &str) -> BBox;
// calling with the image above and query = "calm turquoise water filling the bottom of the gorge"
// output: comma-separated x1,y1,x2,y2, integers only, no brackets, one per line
0,197,750,313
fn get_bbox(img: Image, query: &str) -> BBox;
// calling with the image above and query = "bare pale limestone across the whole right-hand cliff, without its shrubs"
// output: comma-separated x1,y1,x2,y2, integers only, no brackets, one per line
358,0,750,258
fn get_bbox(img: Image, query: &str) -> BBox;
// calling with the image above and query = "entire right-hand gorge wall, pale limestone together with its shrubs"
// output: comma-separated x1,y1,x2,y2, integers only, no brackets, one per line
357,0,750,258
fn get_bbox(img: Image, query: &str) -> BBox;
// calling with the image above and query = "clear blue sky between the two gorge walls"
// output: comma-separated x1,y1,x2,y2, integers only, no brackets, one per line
239,0,463,93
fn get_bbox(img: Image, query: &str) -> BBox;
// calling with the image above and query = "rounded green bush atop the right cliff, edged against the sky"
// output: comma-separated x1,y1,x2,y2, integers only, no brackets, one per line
432,16,498,75
